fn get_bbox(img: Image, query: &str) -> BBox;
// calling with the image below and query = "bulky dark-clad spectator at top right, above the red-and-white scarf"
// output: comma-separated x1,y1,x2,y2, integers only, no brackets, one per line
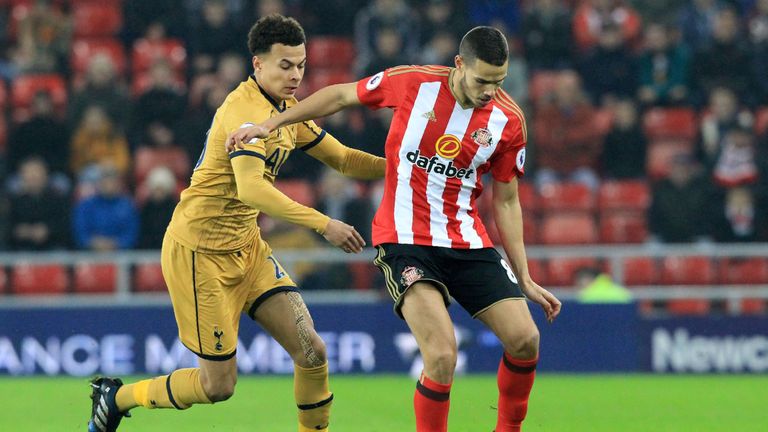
691,9,754,103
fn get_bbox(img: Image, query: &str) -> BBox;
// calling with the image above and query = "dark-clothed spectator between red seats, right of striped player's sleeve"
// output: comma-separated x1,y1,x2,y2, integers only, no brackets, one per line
601,99,647,179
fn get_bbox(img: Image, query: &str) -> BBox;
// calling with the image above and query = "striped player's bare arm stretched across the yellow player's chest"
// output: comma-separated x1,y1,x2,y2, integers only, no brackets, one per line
225,83,360,151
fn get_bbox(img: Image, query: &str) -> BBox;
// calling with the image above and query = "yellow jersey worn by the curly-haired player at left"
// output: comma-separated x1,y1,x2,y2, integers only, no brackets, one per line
168,76,332,253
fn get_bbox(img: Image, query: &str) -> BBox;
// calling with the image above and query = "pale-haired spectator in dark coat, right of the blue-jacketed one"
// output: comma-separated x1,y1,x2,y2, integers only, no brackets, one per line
139,166,179,249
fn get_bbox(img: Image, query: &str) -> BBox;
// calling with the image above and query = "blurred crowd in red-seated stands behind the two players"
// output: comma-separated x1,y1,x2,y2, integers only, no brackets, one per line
0,0,768,294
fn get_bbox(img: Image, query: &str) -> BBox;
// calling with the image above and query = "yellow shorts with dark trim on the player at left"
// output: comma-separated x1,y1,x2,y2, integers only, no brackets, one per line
161,234,298,360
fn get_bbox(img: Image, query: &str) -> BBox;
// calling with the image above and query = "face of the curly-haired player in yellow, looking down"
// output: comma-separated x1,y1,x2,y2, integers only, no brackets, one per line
253,44,307,100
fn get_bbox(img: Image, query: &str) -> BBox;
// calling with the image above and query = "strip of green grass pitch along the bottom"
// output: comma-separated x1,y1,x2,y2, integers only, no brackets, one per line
0,374,768,432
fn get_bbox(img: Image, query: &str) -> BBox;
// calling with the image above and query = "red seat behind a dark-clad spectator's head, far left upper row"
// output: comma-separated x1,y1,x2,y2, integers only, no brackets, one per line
11,75,67,122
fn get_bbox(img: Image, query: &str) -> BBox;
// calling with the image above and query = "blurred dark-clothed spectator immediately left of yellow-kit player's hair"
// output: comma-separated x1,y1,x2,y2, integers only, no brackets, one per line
186,0,245,74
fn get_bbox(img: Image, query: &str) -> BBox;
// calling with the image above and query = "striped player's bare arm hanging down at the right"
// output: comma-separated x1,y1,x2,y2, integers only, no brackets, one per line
493,177,561,322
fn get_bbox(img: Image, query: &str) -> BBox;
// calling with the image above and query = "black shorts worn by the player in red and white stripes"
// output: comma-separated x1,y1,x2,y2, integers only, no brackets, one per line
373,243,525,318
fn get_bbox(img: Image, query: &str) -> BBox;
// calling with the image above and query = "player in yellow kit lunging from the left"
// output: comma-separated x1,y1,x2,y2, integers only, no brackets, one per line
88,15,385,432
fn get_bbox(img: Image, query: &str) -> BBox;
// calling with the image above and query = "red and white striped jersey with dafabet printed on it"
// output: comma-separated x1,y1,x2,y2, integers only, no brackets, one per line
357,62,527,249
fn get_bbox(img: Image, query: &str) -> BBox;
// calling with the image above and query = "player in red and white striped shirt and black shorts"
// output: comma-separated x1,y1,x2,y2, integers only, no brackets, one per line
227,27,561,432
